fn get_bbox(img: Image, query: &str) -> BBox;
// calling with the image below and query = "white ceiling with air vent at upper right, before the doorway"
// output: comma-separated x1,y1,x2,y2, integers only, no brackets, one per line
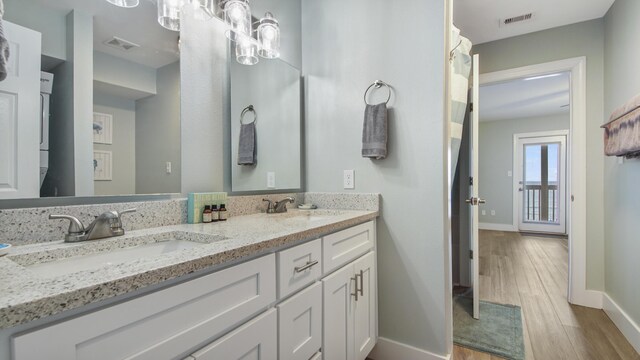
453,0,614,45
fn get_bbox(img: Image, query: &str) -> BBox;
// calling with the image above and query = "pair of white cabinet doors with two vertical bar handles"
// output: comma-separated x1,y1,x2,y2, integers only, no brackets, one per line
322,252,377,360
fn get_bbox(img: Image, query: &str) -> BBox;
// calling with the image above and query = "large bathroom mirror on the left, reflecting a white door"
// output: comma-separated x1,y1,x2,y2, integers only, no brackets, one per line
0,0,181,199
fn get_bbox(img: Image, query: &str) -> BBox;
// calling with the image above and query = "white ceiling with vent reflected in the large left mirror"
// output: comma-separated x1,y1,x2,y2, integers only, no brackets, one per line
26,0,179,68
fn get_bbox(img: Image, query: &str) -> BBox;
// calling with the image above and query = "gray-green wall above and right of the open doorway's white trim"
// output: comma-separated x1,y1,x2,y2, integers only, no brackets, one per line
473,19,604,290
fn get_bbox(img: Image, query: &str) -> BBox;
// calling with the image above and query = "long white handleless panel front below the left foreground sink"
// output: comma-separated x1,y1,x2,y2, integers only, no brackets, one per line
13,254,276,360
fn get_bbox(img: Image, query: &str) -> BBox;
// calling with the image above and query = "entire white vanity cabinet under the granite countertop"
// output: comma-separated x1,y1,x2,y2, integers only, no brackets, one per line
12,221,377,360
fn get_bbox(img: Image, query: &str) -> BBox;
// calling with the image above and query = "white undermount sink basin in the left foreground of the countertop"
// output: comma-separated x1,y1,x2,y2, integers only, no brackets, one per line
26,240,204,277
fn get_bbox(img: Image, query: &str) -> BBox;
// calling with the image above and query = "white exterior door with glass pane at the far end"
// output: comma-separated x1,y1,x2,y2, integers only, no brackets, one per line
515,131,567,234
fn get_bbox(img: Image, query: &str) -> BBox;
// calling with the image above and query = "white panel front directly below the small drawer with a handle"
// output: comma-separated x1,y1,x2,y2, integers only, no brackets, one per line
278,283,322,360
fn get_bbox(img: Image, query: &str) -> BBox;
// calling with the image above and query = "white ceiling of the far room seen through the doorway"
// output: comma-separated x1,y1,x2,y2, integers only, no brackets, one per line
479,73,570,121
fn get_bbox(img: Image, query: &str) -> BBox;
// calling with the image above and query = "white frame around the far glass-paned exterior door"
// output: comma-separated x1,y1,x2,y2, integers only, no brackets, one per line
512,130,571,233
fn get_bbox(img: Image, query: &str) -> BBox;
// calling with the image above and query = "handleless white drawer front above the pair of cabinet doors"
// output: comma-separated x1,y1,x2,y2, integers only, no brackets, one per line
322,221,375,274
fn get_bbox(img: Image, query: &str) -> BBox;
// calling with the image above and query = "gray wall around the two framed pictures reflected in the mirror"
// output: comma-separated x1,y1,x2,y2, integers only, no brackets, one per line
93,92,136,195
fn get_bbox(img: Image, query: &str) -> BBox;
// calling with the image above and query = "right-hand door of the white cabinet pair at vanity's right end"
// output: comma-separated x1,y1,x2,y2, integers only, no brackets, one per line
353,252,378,360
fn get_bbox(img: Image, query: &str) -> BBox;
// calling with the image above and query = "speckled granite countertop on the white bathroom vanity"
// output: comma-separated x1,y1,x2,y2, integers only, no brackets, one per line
0,210,378,329
